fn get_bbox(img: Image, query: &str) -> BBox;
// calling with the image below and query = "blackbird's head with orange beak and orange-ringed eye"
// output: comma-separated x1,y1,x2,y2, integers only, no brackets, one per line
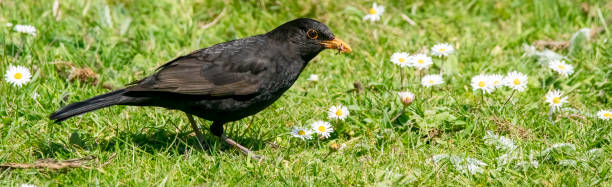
266,18,351,60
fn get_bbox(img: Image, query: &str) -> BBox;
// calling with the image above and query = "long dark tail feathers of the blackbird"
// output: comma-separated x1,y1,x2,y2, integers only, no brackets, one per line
49,89,127,122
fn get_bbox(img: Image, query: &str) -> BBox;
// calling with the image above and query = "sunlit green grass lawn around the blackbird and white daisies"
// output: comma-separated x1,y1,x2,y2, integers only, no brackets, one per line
0,0,612,186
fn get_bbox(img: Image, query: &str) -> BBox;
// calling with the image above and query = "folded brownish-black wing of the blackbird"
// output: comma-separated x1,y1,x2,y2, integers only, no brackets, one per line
128,39,270,97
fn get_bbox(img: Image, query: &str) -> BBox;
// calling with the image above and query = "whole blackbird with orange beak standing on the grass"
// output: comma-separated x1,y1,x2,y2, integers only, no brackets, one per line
49,18,351,159
